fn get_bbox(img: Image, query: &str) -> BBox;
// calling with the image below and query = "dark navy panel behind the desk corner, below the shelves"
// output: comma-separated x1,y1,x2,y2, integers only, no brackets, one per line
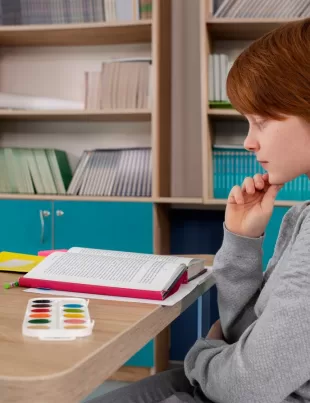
170,209,224,361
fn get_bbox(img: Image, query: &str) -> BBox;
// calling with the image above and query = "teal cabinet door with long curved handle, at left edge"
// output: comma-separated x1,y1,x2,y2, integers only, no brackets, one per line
0,200,52,255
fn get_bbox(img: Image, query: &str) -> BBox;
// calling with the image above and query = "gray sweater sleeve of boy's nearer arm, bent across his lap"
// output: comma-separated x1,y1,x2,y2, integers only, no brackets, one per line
185,218,310,403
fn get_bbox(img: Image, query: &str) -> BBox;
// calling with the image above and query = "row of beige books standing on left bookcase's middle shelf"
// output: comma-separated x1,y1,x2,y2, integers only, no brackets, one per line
85,58,152,110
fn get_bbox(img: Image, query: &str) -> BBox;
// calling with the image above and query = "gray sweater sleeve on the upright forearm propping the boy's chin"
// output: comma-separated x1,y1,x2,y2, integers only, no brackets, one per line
213,225,263,343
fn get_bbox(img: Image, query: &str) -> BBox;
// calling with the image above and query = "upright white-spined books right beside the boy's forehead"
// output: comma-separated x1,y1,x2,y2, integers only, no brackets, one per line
208,53,233,108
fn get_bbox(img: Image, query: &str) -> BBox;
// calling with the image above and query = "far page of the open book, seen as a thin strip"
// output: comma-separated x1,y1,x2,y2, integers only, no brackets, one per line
68,247,195,265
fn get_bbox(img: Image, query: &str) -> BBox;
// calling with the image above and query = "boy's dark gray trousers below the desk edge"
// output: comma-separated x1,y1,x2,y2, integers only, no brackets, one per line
87,368,212,403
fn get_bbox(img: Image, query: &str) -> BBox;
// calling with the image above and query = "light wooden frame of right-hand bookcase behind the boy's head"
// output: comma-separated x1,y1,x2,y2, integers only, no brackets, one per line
200,0,306,208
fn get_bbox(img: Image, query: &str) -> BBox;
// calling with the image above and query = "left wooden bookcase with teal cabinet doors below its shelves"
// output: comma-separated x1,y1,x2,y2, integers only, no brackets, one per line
0,0,177,386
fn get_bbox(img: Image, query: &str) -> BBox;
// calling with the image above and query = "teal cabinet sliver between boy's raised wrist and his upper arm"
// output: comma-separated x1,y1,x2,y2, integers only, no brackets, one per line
263,207,289,270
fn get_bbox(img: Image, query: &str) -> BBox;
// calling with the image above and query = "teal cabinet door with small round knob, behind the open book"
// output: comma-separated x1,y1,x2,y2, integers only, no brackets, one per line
54,201,154,367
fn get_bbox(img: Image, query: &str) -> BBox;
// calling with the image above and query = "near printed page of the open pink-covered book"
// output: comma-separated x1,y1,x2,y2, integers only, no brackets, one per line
26,252,186,291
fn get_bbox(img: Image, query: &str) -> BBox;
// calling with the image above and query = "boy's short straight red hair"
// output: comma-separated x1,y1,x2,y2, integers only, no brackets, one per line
227,18,310,121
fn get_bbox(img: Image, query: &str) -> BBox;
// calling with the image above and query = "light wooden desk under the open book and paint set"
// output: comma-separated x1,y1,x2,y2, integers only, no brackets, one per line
0,256,214,403
